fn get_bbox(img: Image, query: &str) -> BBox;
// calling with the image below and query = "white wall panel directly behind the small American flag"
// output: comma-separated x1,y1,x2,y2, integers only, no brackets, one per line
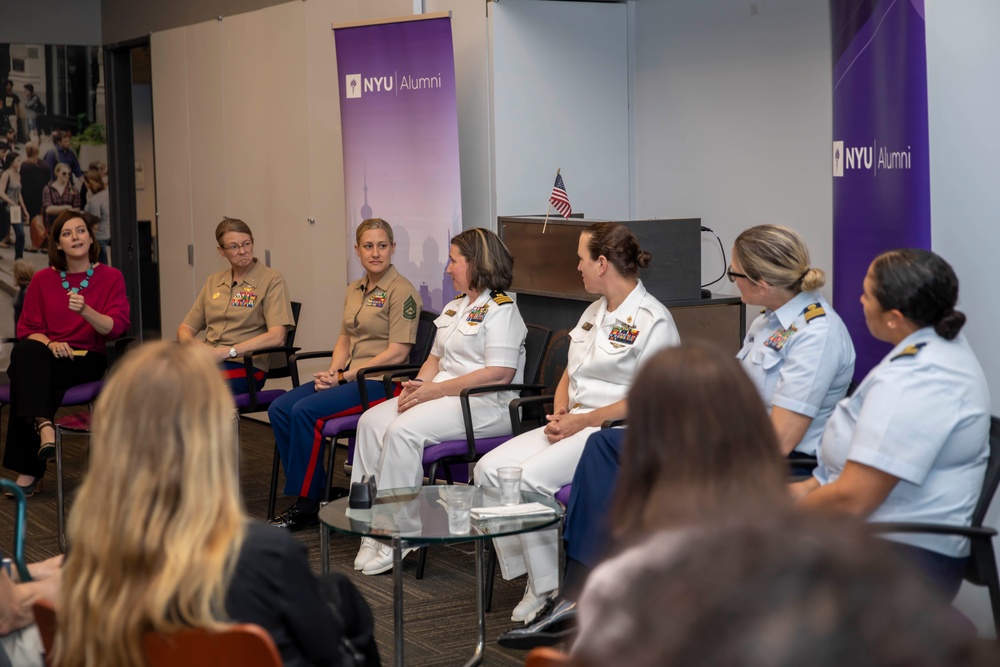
491,0,630,219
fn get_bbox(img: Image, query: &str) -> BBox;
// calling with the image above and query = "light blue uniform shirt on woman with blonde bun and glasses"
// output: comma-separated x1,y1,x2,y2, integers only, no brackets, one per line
736,292,854,454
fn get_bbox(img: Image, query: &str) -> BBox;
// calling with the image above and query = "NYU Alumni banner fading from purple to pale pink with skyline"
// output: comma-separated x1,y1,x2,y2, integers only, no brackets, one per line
334,14,462,312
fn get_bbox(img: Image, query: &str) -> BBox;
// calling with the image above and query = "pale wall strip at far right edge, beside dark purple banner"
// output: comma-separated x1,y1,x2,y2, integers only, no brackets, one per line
925,0,1000,636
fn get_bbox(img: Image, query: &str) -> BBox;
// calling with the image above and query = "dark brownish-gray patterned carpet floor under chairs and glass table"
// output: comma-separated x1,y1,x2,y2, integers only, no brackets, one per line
0,410,544,667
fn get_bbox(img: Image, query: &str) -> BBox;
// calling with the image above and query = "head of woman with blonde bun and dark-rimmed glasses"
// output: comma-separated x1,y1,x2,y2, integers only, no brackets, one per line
733,225,826,294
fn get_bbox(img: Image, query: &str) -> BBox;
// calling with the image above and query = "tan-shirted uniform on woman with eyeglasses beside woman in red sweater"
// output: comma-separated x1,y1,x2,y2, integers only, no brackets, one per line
184,259,295,394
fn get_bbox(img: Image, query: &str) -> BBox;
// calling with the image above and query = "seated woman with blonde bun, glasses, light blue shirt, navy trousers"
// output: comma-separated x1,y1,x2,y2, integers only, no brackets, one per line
499,225,854,648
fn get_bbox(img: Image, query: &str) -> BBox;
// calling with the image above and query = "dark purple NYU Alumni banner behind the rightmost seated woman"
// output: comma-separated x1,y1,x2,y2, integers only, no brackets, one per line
830,0,931,380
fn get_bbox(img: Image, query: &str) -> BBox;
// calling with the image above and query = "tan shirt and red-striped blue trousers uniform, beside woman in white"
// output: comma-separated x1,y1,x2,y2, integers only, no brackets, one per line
267,266,423,499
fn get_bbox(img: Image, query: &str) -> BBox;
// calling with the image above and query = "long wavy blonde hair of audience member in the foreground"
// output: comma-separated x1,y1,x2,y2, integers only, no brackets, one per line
52,342,247,667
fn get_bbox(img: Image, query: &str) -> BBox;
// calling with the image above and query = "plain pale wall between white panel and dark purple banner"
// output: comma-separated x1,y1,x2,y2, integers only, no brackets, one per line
629,0,833,296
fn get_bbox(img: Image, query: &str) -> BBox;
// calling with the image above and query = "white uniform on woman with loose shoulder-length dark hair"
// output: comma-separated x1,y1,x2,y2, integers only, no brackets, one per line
351,292,528,489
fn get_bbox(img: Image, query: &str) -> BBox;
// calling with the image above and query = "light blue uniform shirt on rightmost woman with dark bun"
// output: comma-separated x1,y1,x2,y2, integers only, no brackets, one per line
813,327,990,557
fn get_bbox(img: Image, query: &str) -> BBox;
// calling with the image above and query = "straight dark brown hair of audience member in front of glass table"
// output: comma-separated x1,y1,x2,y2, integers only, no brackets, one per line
613,342,788,541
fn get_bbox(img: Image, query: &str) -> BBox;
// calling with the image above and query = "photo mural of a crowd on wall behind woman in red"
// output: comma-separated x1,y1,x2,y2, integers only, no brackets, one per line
0,43,111,358
